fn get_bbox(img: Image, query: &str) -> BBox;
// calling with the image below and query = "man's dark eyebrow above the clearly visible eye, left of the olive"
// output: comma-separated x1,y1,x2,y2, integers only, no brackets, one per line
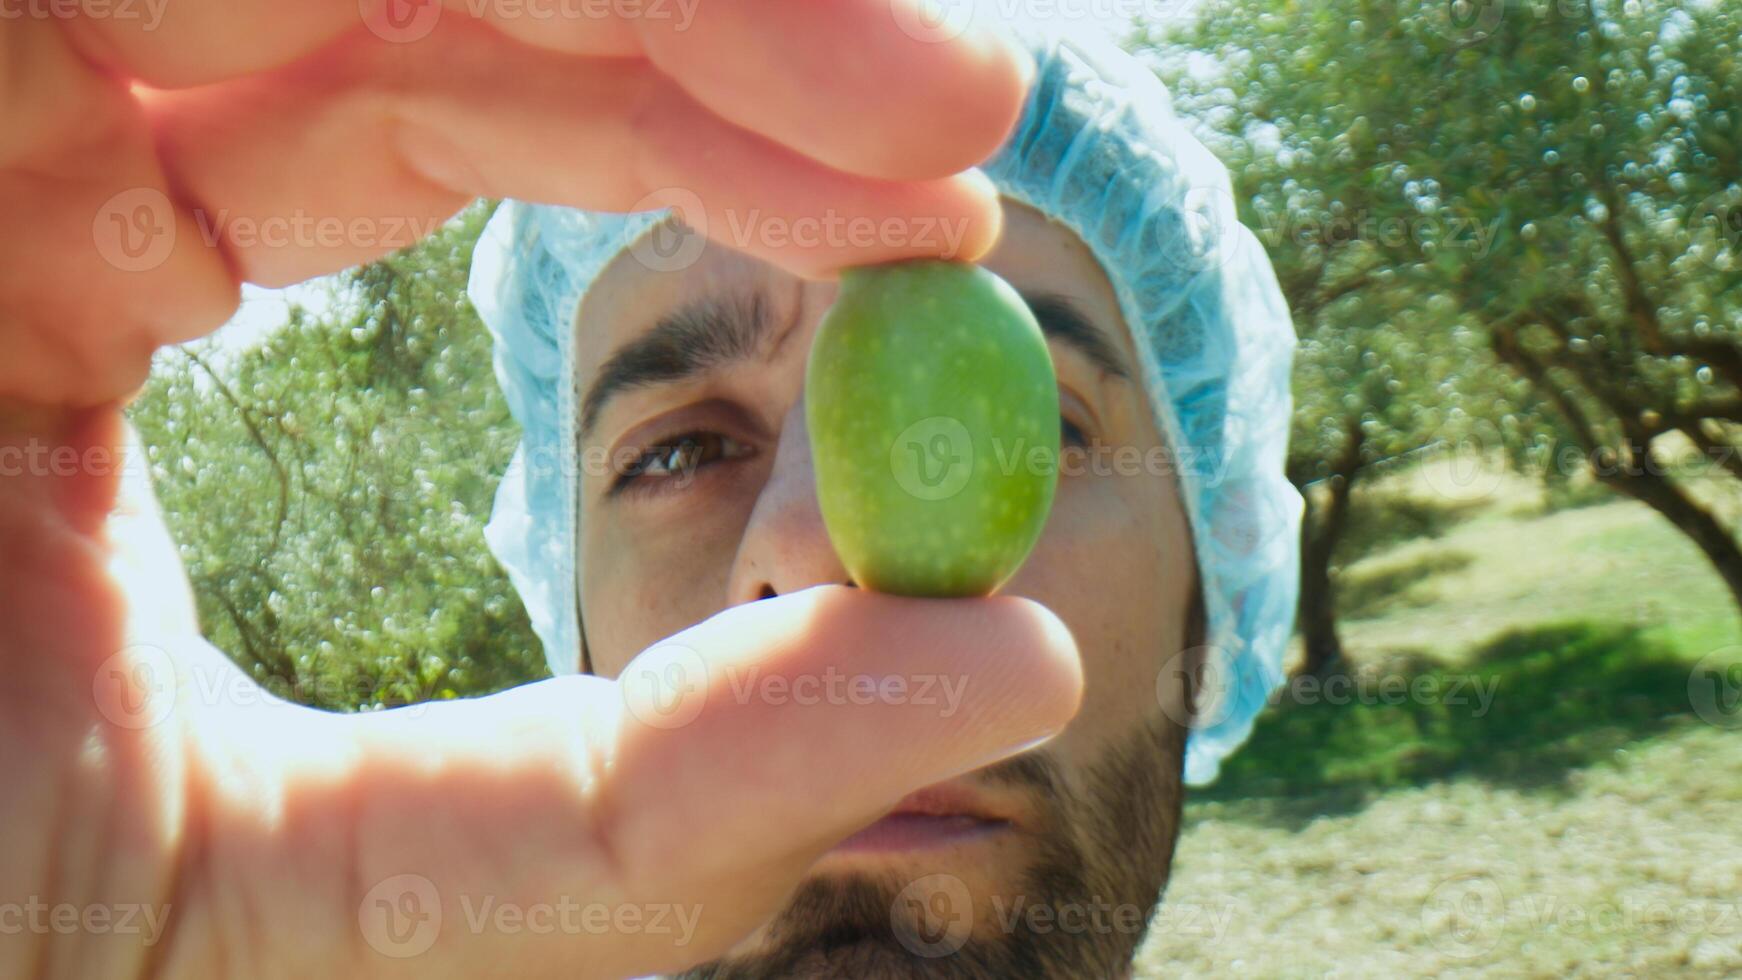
580,292,768,439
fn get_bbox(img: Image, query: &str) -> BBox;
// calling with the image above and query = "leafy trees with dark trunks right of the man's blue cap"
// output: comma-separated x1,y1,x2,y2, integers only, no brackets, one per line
1138,0,1742,670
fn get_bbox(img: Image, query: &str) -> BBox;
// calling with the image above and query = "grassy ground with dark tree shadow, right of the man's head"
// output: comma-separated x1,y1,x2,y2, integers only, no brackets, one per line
1138,463,1742,978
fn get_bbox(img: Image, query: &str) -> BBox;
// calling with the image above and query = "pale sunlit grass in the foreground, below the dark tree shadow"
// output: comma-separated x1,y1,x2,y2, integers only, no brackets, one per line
1139,724,1742,978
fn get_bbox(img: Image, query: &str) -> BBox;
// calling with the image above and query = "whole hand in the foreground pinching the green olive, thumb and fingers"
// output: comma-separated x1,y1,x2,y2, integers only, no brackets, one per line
0,0,1080,977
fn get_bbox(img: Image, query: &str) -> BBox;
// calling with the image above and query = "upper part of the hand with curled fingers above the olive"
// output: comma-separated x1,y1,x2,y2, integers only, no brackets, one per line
0,0,1030,406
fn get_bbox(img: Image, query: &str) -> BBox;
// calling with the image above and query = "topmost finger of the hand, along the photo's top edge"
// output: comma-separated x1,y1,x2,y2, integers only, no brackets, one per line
71,0,1033,181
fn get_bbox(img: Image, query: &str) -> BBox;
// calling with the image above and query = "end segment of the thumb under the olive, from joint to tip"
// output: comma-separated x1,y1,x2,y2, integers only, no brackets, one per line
598,587,1082,888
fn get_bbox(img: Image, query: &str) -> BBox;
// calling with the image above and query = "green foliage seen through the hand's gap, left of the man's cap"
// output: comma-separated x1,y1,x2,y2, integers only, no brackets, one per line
129,205,544,710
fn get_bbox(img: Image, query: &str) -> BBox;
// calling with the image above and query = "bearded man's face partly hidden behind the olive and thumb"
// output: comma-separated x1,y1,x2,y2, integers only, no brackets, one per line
575,202,1202,980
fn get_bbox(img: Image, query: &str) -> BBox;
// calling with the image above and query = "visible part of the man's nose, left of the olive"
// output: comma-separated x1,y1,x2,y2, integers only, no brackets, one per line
728,399,850,604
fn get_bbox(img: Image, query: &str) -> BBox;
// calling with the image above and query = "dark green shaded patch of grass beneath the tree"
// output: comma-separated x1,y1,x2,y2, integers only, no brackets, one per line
1200,623,1693,799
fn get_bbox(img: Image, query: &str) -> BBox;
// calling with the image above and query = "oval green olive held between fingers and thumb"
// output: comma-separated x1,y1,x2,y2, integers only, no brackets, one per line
805,259,1059,597
